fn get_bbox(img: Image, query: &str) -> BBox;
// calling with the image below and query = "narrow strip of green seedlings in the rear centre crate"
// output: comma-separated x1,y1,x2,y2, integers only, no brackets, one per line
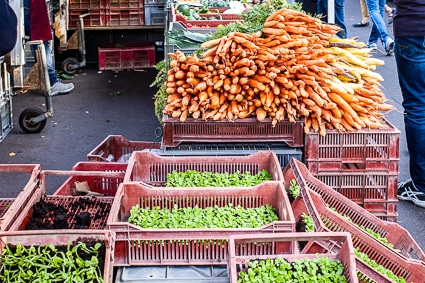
165,169,272,187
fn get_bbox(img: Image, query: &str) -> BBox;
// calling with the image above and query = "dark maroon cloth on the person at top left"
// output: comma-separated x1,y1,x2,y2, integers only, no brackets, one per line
30,0,53,41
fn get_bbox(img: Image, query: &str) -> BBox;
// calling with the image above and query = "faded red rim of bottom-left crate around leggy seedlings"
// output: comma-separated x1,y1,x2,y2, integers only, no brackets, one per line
0,230,115,283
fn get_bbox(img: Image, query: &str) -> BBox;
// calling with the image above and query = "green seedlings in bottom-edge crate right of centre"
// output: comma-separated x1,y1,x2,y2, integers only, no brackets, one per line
238,256,347,283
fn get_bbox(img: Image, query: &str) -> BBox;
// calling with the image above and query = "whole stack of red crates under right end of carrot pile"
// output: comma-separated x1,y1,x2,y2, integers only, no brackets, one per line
304,120,400,221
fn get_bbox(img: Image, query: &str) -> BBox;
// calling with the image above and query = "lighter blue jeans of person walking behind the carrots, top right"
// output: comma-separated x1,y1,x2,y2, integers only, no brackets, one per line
366,0,391,44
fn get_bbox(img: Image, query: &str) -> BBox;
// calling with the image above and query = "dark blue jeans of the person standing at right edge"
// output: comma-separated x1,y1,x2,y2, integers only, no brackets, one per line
394,36,425,193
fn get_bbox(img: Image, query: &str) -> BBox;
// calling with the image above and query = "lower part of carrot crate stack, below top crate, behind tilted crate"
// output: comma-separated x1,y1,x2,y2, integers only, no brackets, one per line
313,170,398,221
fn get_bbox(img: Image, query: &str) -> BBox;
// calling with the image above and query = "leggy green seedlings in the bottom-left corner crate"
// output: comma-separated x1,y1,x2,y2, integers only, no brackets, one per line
0,242,105,283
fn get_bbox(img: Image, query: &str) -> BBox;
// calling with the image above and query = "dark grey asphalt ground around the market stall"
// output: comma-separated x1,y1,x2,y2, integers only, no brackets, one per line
0,0,425,258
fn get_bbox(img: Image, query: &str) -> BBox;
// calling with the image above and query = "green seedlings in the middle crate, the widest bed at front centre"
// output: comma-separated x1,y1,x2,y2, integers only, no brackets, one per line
128,204,279,229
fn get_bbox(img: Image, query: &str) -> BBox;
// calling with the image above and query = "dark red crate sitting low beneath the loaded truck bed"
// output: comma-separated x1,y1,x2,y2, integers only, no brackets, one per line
98,42,155,70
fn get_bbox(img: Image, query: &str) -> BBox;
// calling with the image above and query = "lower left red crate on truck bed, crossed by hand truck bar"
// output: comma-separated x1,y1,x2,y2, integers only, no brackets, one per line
68,8,107,28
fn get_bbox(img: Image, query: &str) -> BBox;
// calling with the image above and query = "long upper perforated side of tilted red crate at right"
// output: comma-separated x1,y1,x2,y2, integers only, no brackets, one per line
284,159,425,261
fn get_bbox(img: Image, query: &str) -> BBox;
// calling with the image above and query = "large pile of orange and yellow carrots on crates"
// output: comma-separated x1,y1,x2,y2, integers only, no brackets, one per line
164,9,393,135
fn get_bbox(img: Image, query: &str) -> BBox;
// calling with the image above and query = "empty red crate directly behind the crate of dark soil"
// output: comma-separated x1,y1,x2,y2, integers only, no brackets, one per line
51,162,127,197
